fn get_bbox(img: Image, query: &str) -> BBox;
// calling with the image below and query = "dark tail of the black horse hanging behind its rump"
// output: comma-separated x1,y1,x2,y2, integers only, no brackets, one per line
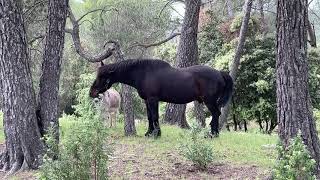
218,71,233,107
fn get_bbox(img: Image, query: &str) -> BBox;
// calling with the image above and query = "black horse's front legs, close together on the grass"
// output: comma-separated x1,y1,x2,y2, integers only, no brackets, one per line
147,98,161,137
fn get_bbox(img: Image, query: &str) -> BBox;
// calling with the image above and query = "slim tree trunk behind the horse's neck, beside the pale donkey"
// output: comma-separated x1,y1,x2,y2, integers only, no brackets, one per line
113,42,137,136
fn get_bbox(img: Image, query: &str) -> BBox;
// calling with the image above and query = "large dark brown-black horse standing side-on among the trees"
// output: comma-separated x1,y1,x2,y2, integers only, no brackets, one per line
90,59,233,136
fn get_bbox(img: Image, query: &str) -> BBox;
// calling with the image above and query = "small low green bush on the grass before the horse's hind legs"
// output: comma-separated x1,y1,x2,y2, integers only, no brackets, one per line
180,123,214,170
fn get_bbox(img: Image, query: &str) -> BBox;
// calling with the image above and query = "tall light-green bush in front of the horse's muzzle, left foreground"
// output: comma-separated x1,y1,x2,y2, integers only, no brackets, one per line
40,74,110,180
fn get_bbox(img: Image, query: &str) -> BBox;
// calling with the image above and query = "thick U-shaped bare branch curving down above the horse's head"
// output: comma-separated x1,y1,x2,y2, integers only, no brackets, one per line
65,7,114,62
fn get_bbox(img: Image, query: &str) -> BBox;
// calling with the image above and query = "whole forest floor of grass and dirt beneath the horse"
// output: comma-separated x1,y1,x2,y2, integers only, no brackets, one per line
0,119,277,180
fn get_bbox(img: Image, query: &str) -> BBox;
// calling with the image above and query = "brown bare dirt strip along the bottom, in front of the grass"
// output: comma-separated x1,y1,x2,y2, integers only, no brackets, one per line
0,143,269,180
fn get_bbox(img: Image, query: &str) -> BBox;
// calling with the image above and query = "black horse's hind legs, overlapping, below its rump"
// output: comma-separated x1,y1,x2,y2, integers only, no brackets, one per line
205,98,221,136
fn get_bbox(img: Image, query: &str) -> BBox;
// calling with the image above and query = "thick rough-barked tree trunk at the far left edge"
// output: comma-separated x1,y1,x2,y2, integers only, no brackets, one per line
0,0,43,174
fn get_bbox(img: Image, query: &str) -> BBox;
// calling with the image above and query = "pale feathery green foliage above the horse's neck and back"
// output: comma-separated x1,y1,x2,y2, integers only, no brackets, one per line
79,0,171,56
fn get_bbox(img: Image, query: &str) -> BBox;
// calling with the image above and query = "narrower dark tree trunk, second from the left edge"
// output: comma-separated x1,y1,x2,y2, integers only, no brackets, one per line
37,0,68,146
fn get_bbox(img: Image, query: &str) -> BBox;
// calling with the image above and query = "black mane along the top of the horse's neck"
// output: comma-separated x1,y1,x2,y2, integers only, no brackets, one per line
103,59,170,72
